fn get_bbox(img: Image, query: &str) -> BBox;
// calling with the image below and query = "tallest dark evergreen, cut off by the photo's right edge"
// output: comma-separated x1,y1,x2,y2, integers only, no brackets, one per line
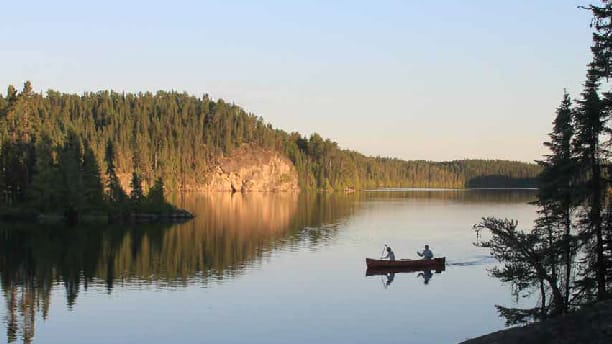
574,0,612,302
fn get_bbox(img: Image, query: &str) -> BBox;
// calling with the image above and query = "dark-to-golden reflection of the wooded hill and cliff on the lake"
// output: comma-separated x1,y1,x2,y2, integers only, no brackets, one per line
0,193,357,343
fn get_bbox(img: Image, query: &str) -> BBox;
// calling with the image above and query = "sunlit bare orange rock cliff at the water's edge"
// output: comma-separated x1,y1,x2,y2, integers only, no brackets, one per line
204,145,299,192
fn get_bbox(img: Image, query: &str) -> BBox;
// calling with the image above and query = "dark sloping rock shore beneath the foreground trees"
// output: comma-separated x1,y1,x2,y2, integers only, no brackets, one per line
461,300,612,344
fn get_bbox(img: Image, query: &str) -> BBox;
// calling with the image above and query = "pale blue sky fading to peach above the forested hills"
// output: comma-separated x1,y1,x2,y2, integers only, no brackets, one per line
0,0,591,161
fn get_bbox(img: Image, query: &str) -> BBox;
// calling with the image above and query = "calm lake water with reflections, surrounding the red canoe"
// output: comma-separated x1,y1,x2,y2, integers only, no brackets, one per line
0,189,535,343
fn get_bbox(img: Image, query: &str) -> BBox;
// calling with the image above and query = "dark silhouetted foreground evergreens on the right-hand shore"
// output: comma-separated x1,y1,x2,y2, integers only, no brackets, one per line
476,0,612,323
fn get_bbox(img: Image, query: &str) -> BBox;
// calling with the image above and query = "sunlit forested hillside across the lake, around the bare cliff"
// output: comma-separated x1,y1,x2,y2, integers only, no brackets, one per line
0,82,539,207
